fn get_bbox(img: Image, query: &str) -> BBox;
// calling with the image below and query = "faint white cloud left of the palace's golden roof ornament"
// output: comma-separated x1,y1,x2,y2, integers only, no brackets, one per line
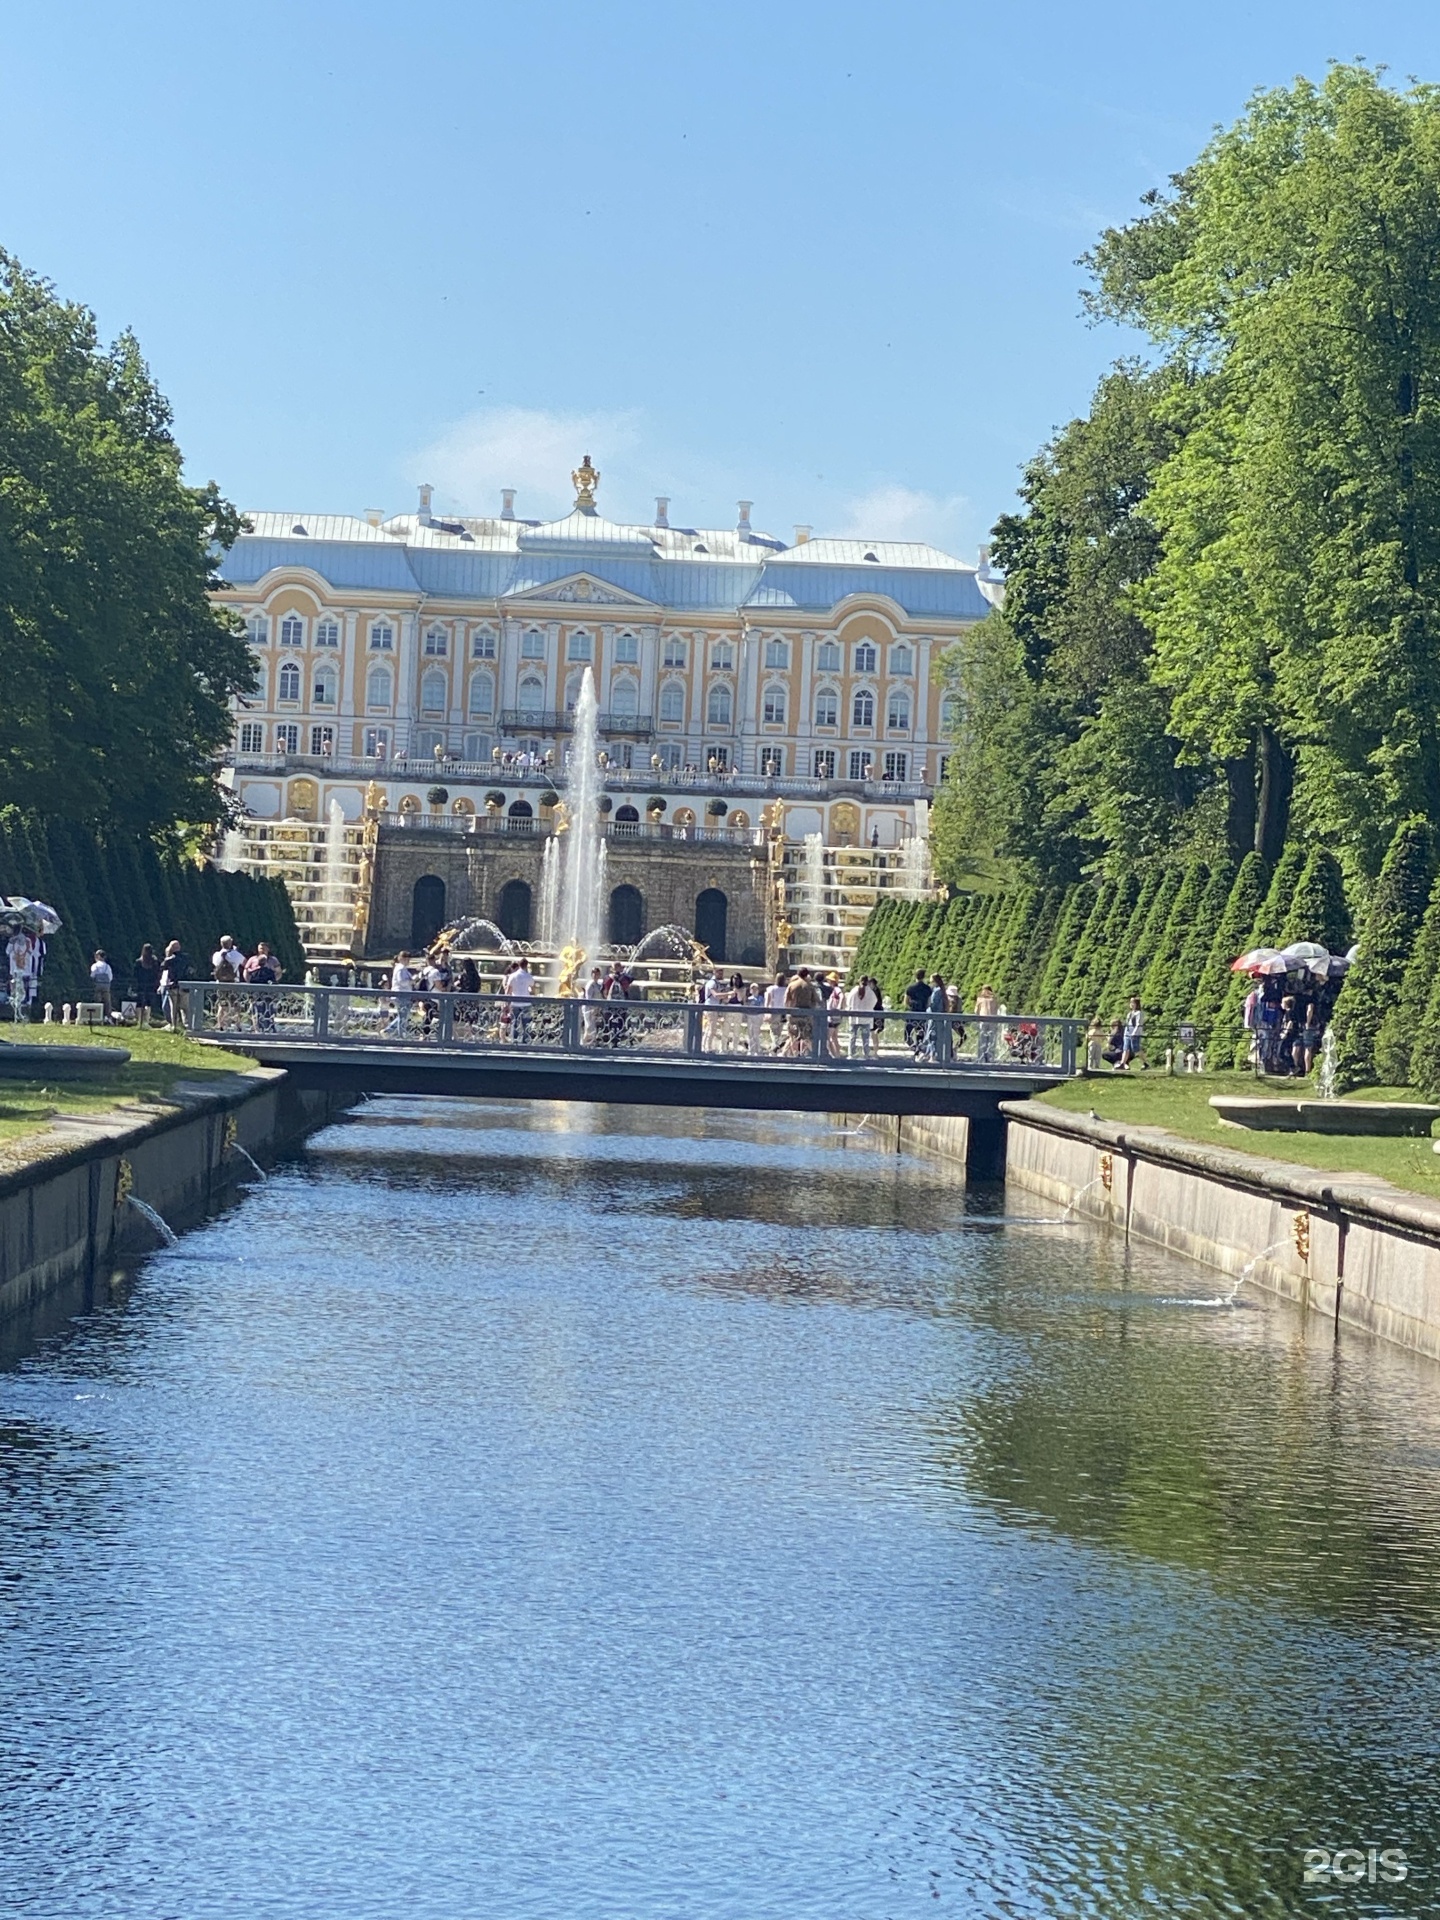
407,407,639,520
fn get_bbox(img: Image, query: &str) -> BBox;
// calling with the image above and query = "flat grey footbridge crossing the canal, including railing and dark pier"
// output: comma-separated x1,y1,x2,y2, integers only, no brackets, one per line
184,981,1081,1177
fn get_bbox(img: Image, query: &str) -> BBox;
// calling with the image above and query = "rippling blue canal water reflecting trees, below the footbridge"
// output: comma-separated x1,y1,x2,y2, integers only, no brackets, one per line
0,1100,1440,1920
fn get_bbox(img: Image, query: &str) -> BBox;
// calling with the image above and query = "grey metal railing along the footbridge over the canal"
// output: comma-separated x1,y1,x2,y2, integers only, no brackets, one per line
182,981,1083,1075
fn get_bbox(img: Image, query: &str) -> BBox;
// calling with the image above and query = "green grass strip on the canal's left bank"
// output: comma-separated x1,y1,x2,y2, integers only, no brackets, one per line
0,1025,248,1165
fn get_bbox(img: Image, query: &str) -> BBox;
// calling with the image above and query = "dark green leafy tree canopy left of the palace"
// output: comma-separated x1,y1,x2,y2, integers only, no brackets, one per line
0,253,253,833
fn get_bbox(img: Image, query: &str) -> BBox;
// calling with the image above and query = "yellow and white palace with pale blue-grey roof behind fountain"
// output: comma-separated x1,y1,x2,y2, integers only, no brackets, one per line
219,457,1000,967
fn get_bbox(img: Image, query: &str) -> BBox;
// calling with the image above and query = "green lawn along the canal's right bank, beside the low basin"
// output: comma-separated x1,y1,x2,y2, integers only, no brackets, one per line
1043,1071,1440,1196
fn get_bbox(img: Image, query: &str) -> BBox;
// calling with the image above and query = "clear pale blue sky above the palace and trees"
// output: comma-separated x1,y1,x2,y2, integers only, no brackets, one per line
0,0,1440,557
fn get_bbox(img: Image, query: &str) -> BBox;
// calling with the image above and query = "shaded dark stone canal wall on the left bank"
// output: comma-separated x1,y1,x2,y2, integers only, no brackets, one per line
0,1068,351,1319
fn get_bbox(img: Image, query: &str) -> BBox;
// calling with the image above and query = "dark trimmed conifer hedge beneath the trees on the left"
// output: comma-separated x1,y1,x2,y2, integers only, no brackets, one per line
0,806,305,1000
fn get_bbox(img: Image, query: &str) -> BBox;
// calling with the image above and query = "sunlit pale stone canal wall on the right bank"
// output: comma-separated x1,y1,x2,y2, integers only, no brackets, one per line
1006,1100,1440,1359
